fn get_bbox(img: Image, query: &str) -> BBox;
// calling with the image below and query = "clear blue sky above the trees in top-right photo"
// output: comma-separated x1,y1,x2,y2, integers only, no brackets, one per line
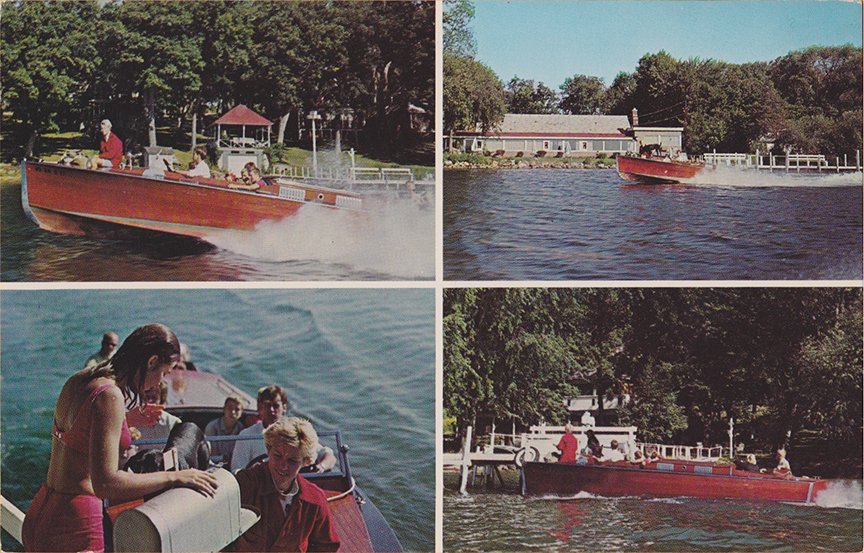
472,0,862,91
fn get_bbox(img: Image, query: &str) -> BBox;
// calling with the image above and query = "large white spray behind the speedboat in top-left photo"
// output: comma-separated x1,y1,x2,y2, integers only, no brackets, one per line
206,196,435,280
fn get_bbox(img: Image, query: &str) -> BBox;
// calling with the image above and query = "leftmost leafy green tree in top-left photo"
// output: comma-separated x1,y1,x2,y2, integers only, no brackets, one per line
0,1,101,157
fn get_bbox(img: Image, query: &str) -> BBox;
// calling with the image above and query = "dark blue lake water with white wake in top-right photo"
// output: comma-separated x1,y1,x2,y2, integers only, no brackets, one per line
443,168,864,280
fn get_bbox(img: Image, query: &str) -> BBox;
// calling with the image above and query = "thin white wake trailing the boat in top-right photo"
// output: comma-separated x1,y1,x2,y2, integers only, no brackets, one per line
688,165,864,188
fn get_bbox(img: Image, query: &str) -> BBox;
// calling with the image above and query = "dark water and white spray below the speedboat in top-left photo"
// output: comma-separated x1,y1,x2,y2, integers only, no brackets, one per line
0,179,435,282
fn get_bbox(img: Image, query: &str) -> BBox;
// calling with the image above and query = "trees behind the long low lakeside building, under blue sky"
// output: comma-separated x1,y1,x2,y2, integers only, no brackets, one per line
444,0,864,155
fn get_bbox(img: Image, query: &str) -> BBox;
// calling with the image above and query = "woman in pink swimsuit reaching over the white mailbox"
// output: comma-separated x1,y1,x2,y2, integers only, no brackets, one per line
22,324,216,551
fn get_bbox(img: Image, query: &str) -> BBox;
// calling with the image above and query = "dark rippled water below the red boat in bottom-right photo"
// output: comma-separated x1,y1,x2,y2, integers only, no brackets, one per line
443,475,864,552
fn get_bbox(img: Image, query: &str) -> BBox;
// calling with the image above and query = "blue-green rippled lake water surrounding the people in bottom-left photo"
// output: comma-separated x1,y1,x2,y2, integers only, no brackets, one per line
0,289,435,551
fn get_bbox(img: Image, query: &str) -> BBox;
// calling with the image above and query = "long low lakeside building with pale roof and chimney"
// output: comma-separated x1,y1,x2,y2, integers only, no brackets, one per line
452,109,684,157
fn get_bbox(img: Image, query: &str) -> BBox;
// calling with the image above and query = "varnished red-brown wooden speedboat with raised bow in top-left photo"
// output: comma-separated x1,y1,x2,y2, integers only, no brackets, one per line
21,160,362,238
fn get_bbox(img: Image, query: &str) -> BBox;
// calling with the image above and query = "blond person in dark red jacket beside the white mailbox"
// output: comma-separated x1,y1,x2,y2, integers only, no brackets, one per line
232,417,340,552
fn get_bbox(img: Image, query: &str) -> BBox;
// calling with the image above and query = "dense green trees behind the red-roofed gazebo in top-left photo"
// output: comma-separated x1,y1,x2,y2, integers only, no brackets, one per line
0,0,435,160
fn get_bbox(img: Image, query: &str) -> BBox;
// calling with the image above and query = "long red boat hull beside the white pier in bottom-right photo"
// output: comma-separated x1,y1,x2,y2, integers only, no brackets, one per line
522,460,828,503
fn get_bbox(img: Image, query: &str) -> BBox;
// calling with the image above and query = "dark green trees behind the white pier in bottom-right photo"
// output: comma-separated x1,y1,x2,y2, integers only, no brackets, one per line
443,288,864,472
